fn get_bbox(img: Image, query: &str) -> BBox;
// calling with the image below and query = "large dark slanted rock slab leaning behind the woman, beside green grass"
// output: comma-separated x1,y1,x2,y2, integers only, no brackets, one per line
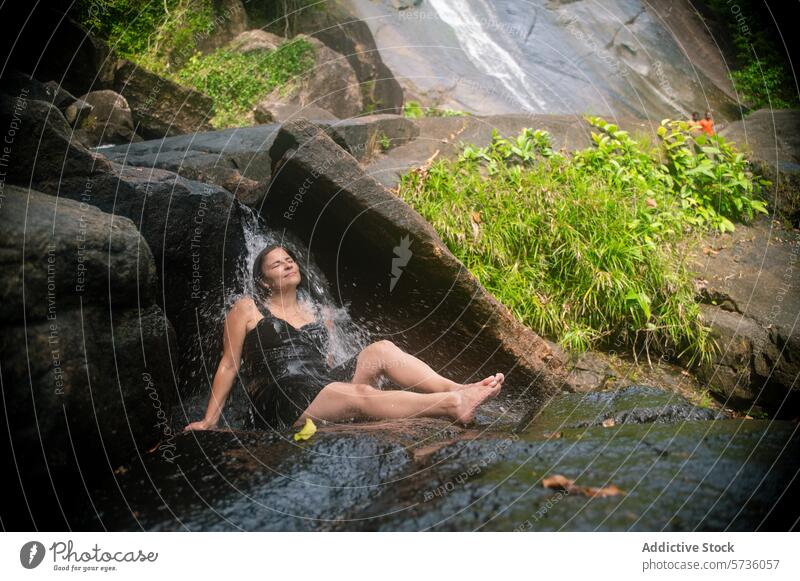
258,121,563,399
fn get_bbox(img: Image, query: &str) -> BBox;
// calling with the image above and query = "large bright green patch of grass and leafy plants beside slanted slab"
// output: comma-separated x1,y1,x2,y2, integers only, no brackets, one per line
399,118,764,362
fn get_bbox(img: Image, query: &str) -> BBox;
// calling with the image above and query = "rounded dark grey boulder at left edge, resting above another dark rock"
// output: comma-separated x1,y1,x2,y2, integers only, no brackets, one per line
0,186,156,324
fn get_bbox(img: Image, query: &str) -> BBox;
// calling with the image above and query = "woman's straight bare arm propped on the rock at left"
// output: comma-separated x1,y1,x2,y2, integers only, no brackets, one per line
184,299,251,431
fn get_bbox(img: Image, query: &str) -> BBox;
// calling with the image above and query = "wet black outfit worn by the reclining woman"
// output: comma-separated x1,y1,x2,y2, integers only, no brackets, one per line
242,301,356,429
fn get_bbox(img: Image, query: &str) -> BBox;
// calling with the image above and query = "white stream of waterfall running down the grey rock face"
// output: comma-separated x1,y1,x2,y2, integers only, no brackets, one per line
428,0,547,113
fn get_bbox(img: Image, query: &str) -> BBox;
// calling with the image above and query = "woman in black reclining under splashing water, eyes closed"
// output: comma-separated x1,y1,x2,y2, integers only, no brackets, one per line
184,246,504,431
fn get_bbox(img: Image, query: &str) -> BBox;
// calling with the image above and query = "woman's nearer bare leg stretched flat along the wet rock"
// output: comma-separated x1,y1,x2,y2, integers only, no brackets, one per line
294,382,500,426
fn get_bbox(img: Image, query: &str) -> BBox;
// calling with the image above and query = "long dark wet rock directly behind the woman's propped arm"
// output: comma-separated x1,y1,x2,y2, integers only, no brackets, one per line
0,87,250,392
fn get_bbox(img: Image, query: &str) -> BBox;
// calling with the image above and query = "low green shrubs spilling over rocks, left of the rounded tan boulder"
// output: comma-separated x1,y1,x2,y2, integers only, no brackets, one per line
176,39,314,127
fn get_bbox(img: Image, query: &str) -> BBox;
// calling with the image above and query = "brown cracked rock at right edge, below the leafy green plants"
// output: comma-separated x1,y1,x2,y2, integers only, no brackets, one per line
693,217,800,418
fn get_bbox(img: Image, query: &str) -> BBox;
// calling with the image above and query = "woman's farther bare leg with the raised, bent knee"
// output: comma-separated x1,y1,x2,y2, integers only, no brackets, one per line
352,341,505,393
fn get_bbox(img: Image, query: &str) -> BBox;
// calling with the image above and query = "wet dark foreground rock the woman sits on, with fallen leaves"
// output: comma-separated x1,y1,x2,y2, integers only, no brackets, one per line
65,386,800,531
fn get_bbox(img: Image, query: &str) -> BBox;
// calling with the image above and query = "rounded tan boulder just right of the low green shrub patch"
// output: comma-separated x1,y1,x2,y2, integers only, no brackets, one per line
262,34,363,119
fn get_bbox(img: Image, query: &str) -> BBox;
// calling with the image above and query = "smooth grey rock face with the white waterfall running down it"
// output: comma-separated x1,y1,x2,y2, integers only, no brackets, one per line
344,0,738,119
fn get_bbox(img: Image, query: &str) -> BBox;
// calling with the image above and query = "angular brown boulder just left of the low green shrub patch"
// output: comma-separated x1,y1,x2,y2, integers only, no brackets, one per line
114,59,214,139
